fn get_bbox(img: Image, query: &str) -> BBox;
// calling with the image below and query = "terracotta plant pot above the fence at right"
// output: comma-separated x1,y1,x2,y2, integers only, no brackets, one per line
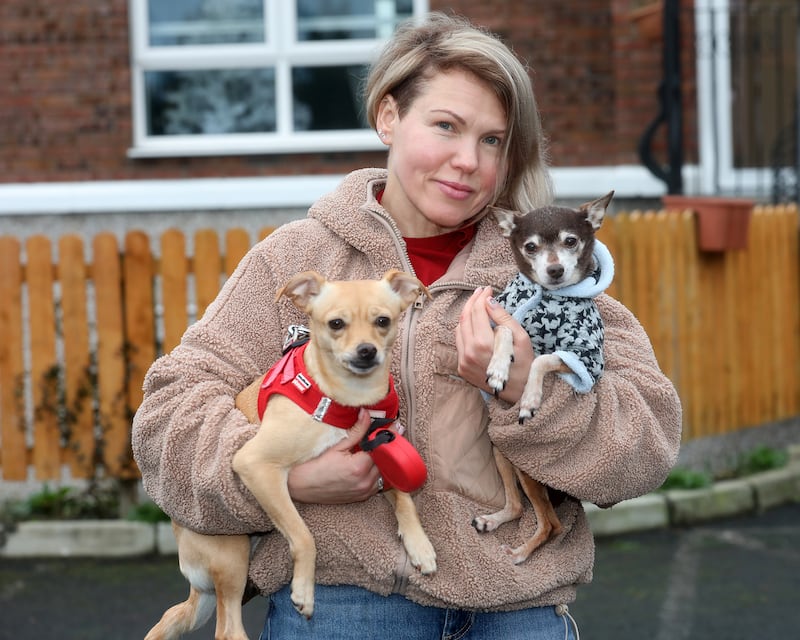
663,196,754,251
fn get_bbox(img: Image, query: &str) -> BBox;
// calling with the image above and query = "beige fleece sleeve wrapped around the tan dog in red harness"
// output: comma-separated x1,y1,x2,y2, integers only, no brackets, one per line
132,252,284,534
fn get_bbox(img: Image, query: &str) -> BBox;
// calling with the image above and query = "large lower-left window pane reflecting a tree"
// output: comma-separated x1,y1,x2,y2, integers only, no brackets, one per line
145,69,276,136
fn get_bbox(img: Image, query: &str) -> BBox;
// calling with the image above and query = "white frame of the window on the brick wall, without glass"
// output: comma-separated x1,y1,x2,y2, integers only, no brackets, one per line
128,0,428,158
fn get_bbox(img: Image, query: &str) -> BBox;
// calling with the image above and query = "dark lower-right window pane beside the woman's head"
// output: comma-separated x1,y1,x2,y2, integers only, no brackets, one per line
292,65,367,131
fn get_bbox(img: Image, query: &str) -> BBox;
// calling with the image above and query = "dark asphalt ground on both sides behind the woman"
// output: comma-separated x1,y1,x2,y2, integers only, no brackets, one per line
0,505,800,640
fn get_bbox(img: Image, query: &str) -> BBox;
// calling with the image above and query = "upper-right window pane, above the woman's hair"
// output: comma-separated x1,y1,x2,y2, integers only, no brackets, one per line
297,0,412,41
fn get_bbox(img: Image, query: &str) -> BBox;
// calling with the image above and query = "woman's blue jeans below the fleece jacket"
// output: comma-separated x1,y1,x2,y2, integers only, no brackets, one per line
260,585,575,640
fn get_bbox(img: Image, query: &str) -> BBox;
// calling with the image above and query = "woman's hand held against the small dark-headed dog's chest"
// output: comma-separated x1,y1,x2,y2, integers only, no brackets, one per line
456,287,534,403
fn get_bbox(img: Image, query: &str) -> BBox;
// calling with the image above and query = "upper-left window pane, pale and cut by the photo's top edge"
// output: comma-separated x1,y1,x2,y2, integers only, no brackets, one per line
147,0,264,46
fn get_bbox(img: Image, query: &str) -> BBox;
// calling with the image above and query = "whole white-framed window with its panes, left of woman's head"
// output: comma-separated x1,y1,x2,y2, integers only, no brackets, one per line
128,0,427,157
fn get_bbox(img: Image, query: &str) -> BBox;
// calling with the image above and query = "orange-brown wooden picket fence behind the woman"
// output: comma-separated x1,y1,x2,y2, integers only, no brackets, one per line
0,206,800,481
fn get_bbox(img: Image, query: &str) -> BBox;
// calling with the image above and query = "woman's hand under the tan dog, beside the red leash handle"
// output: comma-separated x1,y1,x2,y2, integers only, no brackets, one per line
289,409,380,504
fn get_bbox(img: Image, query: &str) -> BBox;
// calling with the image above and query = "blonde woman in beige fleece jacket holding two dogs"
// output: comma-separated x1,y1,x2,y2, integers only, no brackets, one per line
133,14,680,640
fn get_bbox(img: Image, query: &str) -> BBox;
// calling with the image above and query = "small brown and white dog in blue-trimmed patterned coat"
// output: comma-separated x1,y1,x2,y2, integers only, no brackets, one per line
472,191,614,564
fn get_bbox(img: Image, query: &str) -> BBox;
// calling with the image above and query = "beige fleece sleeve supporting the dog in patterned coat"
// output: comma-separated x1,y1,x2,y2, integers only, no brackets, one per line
490,295,681,506
